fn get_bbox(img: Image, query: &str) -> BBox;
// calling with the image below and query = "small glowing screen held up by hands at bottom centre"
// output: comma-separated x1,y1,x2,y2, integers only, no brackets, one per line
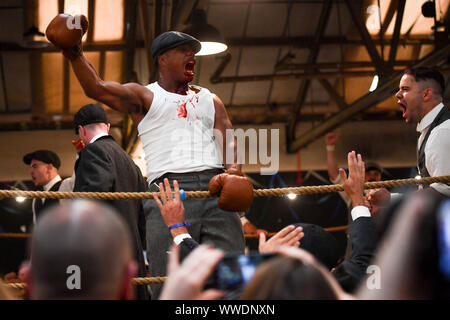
216,254,273,290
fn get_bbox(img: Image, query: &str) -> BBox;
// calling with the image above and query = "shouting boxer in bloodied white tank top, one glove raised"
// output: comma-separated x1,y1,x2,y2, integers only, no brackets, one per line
46,15,253,298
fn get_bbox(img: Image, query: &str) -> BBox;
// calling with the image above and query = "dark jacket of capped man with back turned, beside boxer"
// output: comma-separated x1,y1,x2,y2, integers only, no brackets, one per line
73,136,148,299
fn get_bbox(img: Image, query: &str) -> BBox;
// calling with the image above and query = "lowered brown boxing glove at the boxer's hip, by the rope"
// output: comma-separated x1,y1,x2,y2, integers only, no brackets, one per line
208,169,253,211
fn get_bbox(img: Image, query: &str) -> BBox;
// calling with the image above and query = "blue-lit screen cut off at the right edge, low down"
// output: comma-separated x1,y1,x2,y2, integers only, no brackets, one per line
437,201,450,280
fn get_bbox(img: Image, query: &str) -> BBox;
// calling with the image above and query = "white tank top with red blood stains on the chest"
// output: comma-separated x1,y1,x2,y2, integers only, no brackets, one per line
137,82,223,183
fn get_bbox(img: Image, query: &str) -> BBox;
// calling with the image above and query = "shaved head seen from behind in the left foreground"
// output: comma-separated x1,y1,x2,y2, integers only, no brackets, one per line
24,200,137,300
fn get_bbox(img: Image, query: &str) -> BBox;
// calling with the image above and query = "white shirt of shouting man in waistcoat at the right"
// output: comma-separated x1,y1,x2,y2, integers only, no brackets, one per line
417,103,450,196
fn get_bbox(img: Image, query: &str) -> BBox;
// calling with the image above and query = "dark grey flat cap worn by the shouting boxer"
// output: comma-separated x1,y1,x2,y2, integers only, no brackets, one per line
152,31,202,64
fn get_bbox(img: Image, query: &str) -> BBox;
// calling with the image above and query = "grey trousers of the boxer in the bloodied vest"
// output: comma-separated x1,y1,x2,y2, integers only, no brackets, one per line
144,169,245,299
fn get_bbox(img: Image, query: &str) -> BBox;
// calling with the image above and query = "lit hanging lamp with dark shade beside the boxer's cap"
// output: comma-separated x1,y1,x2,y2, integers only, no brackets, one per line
183,9,228,56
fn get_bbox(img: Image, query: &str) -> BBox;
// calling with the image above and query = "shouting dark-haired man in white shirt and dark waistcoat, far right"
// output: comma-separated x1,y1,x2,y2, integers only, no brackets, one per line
367,67,450,210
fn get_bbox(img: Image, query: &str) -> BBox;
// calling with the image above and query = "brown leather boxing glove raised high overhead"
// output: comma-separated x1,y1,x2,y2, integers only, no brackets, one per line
45,14,89,60
